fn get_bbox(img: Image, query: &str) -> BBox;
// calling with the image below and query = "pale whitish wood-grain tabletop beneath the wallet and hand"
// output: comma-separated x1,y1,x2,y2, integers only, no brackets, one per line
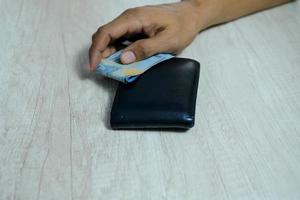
0,0,300,200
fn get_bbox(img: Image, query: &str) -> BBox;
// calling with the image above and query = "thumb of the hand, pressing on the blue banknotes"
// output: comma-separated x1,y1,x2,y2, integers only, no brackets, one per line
121,31,177,64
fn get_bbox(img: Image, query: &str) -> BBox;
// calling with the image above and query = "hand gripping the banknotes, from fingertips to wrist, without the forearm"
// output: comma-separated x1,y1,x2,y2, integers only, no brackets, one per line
89,1,206,69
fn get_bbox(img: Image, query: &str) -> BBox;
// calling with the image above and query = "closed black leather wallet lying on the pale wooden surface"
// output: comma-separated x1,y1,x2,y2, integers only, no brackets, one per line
110,58,200,129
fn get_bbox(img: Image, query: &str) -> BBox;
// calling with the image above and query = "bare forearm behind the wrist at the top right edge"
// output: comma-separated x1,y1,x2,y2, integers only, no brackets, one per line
183,0,292,30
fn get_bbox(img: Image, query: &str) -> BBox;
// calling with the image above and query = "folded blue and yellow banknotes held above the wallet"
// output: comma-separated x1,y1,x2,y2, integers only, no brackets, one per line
96,50,174,83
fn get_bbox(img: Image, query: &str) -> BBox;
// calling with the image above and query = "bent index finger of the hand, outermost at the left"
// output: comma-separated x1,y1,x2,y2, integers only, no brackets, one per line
89,11,142,69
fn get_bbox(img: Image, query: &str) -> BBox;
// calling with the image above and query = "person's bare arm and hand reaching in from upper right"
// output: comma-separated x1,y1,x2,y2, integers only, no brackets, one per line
89,0,290,70
